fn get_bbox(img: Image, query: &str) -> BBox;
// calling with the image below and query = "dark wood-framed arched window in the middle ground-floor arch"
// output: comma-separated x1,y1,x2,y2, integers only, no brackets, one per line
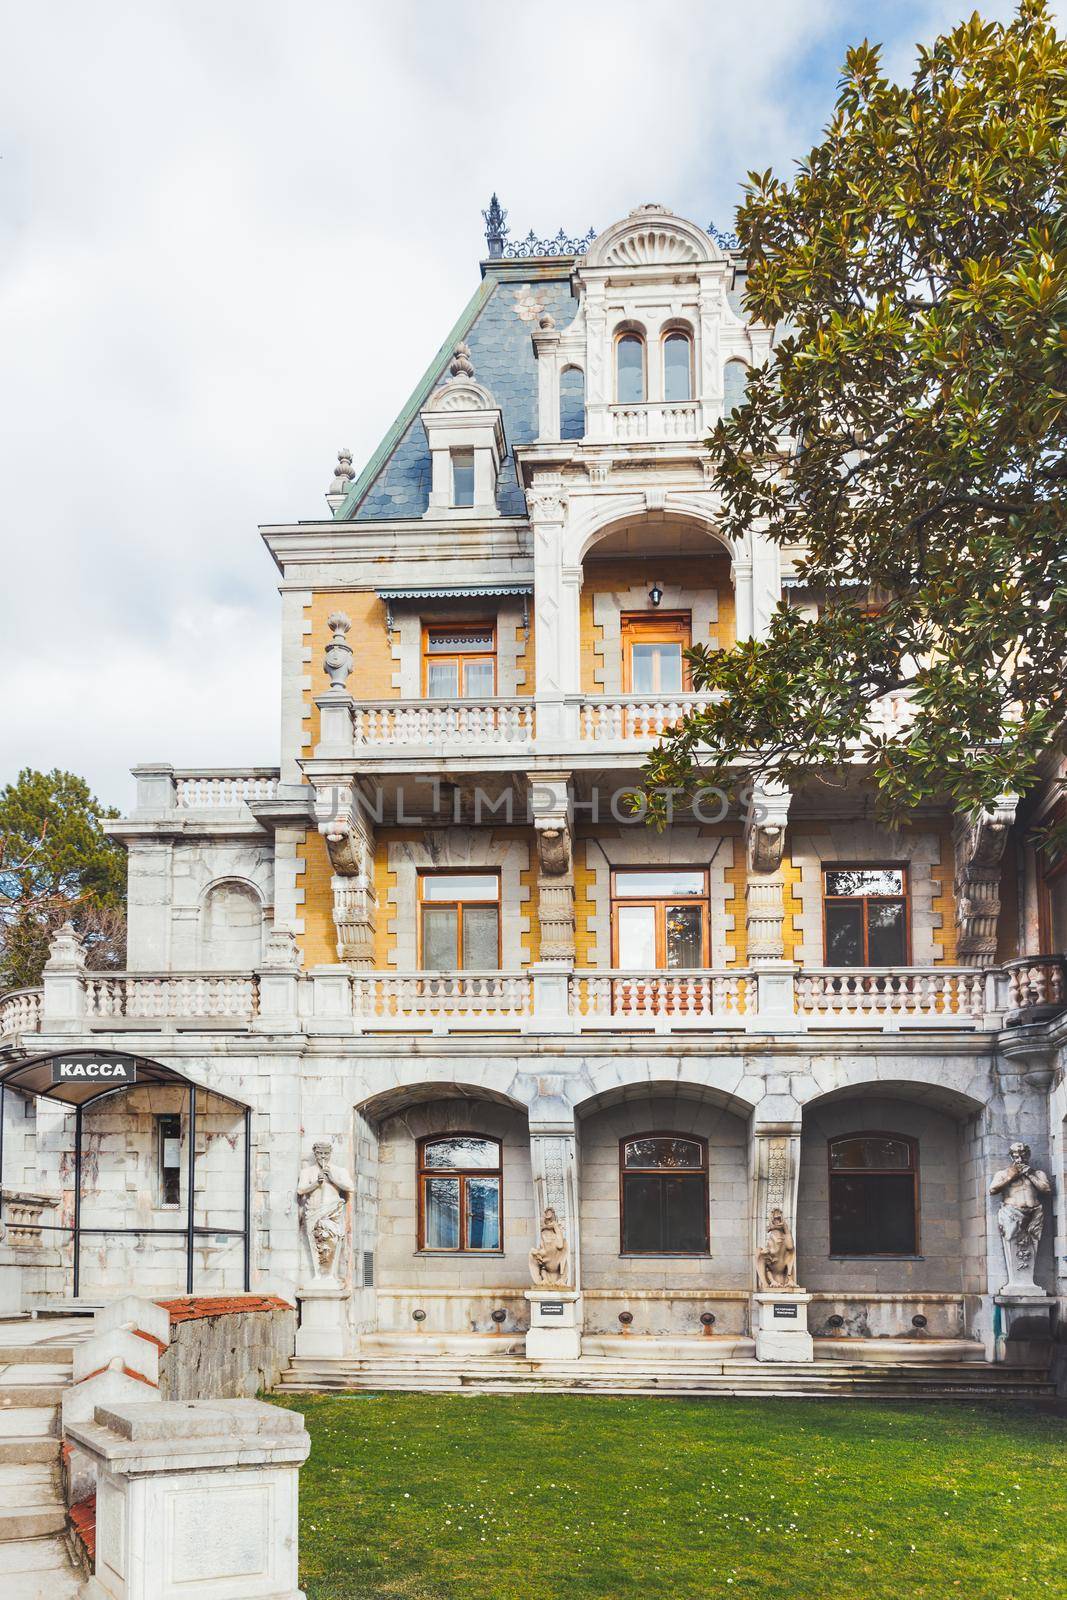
619,1133,710,1256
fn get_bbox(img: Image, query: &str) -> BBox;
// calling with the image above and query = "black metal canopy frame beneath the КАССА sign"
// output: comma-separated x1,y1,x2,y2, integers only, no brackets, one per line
0,1051,251,1299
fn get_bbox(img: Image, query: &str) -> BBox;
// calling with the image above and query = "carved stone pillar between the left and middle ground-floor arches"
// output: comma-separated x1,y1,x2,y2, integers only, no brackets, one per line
526,1080,582,1360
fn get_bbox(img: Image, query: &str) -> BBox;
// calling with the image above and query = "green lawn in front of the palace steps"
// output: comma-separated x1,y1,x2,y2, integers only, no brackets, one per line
271,1395,1067,1600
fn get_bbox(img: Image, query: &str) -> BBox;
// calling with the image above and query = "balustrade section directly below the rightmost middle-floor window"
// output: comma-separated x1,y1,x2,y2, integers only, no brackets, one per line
795,966,989,1027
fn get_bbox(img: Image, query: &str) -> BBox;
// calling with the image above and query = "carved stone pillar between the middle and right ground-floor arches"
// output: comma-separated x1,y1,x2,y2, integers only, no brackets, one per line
749,1118,814,1362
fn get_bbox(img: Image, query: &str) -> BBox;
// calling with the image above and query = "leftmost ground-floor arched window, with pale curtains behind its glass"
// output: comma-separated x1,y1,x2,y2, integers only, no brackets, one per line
419,1133,502,1253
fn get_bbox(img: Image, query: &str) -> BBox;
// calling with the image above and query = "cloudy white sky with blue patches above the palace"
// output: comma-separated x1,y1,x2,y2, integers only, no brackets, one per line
0,0,1043,810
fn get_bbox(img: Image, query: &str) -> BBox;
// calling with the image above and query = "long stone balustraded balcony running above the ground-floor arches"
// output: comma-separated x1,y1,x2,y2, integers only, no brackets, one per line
0,957,1036,1050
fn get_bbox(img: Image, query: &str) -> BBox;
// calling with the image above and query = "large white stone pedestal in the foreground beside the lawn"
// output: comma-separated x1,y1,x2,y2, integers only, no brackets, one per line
69,1400,310,1600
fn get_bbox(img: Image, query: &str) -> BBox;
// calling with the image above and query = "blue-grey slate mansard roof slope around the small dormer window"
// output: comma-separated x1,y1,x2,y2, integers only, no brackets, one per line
336,258,577,522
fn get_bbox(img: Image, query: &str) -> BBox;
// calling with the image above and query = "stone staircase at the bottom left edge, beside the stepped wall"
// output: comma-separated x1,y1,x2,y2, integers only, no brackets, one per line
0,1320,83,1600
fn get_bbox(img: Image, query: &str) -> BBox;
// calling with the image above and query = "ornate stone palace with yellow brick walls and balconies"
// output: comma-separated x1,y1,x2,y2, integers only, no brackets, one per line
0,203,1067,1381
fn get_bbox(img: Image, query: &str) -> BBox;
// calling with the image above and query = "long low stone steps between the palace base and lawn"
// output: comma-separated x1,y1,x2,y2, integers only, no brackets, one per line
278,1341,1054,1400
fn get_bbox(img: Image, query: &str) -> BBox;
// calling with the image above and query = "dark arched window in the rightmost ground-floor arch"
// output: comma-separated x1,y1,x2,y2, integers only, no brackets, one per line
829,1133,918,1256
